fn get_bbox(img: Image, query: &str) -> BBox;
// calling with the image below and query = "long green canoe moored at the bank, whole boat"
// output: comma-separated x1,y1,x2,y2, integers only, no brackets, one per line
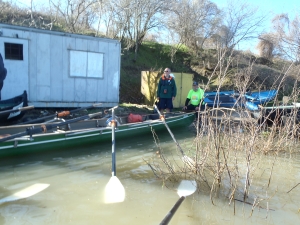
0,113,195,157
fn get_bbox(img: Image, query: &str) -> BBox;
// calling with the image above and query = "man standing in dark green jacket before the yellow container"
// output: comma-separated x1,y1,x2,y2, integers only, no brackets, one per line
156,68,177,113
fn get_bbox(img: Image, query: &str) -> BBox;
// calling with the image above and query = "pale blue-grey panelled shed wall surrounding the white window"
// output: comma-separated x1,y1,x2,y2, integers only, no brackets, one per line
0,24,120,107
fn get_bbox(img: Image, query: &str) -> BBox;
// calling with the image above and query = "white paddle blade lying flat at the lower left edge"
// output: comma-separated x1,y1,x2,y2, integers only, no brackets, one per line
0,184,50,204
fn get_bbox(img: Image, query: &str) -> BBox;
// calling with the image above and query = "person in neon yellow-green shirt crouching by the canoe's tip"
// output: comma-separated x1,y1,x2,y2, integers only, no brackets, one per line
182,81,205,111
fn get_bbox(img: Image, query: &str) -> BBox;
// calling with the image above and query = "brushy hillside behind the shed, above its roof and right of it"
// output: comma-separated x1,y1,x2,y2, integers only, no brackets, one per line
0,1,300,104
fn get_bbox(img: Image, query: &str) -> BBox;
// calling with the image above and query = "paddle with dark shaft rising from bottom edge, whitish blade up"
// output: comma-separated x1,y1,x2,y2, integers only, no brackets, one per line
160,180,197,225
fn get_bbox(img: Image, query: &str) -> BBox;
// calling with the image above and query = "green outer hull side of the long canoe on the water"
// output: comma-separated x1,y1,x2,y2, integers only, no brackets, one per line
0,113,195,156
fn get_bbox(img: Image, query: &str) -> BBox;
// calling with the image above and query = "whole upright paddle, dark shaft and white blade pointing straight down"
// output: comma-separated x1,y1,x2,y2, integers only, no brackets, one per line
105,106,125,203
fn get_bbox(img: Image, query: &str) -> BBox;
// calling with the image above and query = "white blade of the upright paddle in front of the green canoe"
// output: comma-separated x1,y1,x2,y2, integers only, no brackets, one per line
104,176,125,204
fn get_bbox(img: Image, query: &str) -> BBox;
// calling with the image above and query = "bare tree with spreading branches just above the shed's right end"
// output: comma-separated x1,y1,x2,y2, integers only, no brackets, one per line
96,0,169,58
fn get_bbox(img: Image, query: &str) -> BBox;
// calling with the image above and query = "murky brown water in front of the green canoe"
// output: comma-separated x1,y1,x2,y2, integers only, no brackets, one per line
0,129,300,225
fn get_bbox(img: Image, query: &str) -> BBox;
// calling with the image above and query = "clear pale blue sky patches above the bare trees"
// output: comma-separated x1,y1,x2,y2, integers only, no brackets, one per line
8,0,300,53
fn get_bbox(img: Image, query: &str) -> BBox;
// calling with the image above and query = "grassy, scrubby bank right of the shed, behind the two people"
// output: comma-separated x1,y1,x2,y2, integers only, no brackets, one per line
120,42,299,104
